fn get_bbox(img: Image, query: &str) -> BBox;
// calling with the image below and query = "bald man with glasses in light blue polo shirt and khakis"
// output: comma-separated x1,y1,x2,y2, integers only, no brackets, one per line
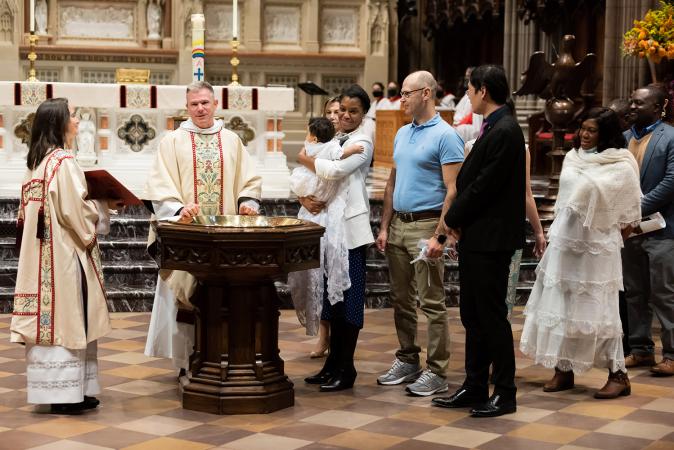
377,71,463,396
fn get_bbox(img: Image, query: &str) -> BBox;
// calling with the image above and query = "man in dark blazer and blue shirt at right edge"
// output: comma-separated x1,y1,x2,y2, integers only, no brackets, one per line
622,85,674,376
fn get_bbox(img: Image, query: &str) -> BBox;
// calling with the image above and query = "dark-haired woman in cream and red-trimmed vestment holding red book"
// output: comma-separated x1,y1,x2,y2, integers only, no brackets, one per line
10,98,111,414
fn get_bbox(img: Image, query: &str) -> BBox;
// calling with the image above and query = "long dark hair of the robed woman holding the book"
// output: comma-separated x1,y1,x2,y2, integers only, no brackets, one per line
26,98,70,170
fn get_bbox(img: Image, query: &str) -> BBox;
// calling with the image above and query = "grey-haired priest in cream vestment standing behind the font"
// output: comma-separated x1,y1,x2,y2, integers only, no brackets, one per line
144,82,262,372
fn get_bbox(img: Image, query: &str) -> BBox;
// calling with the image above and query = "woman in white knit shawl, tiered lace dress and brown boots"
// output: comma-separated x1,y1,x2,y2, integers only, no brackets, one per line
520,108,641,398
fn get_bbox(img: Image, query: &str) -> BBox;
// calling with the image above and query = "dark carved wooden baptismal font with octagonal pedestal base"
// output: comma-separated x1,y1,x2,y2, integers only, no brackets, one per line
153,222,323,414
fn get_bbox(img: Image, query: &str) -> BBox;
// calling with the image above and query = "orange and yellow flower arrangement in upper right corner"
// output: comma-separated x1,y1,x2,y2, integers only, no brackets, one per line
623,0,674,63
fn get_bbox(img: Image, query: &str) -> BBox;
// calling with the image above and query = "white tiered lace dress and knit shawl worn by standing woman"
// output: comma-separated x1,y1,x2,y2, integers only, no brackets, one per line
520,152,640,374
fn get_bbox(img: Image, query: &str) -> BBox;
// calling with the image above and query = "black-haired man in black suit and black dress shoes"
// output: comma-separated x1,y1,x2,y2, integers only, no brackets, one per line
433,65,526,417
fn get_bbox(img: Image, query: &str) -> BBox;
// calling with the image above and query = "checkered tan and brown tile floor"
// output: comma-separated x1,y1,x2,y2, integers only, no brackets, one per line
0,308,674,450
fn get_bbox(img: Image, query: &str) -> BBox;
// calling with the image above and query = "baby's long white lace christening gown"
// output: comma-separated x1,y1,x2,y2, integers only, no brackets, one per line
288,140,351,336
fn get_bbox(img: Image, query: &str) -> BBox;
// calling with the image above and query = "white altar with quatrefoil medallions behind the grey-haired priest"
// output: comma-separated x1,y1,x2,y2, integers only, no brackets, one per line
0,81,294,198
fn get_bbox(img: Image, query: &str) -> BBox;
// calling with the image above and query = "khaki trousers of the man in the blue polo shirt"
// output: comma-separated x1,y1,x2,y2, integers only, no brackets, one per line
386,216,449,377
